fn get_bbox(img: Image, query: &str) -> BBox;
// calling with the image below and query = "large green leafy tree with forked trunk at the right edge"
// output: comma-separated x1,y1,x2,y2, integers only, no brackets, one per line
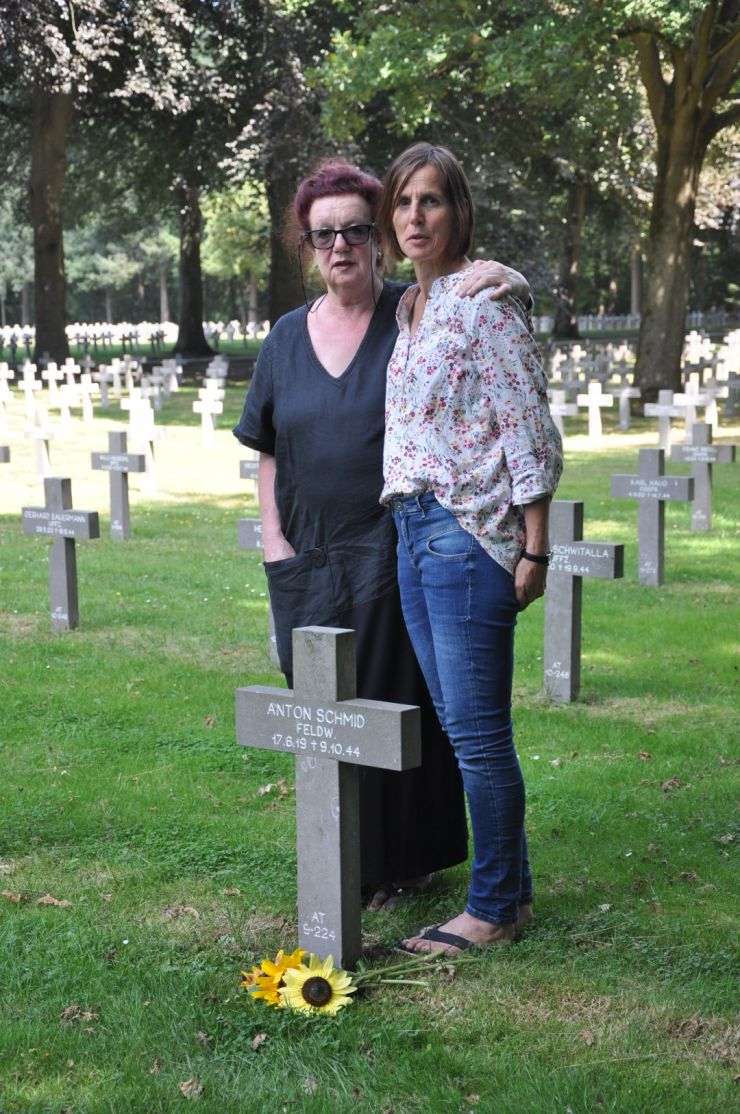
322,0,740,392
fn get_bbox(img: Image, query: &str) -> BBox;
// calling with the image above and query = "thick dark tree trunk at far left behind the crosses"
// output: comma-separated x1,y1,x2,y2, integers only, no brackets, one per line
30,87,74,361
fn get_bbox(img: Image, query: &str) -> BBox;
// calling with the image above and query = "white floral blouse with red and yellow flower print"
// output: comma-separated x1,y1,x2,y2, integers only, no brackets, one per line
381,266,563,571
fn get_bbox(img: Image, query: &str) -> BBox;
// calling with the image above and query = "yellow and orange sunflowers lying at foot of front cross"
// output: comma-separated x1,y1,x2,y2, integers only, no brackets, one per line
240,948,459,1015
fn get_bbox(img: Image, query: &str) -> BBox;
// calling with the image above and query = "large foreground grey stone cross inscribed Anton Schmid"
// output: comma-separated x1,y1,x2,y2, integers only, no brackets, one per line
236,627,421,967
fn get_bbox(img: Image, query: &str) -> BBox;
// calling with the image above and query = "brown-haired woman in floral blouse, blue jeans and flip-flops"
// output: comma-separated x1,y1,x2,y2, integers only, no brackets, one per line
378,144,563,954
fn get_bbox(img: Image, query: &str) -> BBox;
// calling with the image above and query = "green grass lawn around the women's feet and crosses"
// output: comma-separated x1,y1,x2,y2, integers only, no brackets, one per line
0,389,740,1114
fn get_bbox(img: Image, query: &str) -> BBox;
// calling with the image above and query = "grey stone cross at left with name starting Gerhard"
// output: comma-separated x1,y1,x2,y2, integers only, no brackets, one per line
22,476,100,631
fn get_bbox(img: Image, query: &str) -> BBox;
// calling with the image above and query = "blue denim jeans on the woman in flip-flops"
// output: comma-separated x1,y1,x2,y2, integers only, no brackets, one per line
391,492,532,925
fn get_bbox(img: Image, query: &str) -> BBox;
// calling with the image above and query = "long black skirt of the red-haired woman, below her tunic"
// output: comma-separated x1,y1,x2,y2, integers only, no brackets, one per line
337,589,468,886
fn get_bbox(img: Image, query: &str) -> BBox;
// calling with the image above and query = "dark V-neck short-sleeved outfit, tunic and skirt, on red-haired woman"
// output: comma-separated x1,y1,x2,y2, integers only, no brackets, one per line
234,283,468,886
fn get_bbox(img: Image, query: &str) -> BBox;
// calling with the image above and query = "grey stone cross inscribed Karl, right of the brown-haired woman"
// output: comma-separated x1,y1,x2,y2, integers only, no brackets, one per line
612,449,693,587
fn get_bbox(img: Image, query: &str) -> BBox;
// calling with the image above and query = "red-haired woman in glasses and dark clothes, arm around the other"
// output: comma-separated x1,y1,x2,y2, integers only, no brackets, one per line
234,159,528,908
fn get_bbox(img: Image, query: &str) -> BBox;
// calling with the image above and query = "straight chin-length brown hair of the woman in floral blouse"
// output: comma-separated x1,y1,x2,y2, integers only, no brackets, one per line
376,143,475,260
